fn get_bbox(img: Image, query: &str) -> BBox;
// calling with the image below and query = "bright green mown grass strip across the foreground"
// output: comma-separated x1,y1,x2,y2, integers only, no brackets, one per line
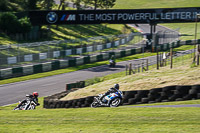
0,100,200,133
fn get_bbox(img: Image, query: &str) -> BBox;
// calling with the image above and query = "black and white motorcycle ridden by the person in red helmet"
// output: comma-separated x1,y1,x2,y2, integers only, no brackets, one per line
13,95,38,110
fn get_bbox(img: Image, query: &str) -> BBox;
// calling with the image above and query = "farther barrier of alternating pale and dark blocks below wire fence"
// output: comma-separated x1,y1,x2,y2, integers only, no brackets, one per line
0,33,133,64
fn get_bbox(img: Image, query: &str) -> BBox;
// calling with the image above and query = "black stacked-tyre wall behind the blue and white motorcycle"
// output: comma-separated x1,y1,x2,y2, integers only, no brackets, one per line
44,82,200,108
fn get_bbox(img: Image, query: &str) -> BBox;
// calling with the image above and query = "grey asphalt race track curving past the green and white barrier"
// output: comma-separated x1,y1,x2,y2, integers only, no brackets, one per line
0,25,178,106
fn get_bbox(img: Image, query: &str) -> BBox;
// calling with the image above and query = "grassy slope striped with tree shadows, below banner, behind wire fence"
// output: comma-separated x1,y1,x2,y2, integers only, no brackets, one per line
0,24,132,45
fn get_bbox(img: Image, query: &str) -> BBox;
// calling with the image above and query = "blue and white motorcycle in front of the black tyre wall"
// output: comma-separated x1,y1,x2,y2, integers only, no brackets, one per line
91,90,123,108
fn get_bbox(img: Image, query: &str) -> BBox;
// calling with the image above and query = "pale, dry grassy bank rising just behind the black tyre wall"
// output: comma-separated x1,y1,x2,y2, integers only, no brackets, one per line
63,54,200,100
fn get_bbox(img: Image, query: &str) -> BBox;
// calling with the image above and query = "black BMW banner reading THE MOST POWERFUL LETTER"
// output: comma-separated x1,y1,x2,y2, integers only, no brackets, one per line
29,7,200,25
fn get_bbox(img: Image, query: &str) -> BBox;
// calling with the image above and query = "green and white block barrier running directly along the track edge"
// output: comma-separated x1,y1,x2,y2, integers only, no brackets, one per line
0,40,200,80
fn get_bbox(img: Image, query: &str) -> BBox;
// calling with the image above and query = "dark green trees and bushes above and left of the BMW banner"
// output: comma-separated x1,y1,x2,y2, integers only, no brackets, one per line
0,0,116,38
